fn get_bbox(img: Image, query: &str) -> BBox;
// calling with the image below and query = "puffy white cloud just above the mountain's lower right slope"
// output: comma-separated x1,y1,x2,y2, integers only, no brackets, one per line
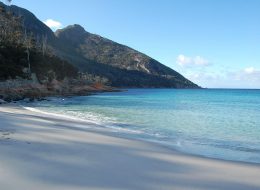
176,54,209,67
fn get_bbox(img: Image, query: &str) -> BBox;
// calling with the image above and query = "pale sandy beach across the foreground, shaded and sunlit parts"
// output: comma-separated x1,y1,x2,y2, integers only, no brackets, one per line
0,105,260,190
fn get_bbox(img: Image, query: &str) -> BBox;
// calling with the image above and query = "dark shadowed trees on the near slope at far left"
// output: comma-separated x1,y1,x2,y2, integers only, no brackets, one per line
0,2,78,81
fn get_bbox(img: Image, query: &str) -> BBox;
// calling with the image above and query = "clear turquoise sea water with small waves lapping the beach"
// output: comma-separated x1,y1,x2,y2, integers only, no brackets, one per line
22,89,260,163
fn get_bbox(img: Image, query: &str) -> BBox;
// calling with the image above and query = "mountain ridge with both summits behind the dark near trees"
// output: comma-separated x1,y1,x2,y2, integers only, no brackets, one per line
0,3,199,88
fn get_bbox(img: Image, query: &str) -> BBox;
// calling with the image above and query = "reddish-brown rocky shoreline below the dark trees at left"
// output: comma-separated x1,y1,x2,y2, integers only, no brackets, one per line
0,79,117,104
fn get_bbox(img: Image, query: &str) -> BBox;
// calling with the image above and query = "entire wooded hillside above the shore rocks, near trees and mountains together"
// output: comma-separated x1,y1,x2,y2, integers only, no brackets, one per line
0,2,199,88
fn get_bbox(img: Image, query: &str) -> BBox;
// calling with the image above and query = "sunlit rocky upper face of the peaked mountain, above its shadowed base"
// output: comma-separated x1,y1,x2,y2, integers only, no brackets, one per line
55,25,187,77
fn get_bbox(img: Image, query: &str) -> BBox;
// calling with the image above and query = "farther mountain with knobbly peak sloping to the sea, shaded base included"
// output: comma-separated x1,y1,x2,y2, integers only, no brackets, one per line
55,25,198,88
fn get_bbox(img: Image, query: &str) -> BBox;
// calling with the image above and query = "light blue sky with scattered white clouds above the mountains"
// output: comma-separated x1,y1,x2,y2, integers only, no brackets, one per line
6,0,260,88
